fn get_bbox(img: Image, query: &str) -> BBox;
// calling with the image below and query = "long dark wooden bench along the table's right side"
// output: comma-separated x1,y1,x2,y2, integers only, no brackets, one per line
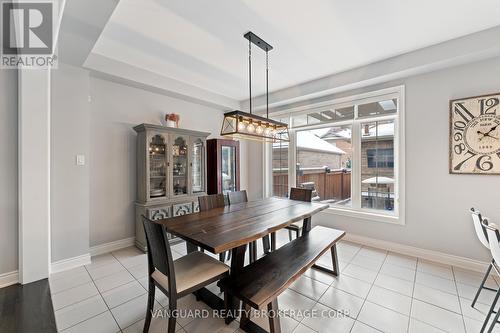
219,226,345,333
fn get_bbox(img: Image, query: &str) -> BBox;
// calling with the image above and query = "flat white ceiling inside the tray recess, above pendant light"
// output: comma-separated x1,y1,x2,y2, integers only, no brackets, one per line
92,0,500,100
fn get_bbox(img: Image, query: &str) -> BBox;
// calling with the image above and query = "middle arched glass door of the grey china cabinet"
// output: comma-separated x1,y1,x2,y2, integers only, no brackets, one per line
172,136,188,195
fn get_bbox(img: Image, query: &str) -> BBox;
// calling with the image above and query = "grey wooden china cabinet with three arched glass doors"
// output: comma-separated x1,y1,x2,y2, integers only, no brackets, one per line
134,124,210,251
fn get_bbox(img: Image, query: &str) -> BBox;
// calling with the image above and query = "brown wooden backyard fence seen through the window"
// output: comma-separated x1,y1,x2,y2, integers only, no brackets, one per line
273,169,351,200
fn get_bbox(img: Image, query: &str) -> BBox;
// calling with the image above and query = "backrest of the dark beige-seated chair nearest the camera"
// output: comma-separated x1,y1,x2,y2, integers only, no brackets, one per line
142,215,177,292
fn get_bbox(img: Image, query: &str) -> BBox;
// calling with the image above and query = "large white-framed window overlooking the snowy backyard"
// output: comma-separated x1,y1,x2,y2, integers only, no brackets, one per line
267,87,404,223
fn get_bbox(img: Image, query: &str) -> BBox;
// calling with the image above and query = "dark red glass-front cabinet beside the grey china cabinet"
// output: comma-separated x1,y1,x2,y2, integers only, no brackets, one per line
207,139,240,194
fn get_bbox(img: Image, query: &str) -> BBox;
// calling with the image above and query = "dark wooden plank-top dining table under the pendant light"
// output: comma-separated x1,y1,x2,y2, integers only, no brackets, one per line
155,197,329,323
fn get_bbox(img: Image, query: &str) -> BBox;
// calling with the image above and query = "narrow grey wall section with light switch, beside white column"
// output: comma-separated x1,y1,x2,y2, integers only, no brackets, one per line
50,63,92,262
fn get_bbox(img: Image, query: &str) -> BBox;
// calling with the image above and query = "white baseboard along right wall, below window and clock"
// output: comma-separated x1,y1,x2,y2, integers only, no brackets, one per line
344,233,489,273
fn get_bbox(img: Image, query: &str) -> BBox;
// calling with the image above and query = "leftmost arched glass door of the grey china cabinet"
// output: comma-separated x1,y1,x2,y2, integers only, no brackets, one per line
148,134,167,199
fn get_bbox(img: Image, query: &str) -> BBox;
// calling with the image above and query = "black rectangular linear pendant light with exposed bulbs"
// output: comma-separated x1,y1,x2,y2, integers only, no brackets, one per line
220,31,289,142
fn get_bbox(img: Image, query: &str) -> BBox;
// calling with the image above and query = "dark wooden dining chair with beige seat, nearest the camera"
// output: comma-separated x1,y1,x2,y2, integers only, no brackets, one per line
142,215,229,333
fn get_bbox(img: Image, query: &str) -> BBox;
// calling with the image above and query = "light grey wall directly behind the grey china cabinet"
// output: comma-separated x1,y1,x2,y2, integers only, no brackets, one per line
89,77,223,246
